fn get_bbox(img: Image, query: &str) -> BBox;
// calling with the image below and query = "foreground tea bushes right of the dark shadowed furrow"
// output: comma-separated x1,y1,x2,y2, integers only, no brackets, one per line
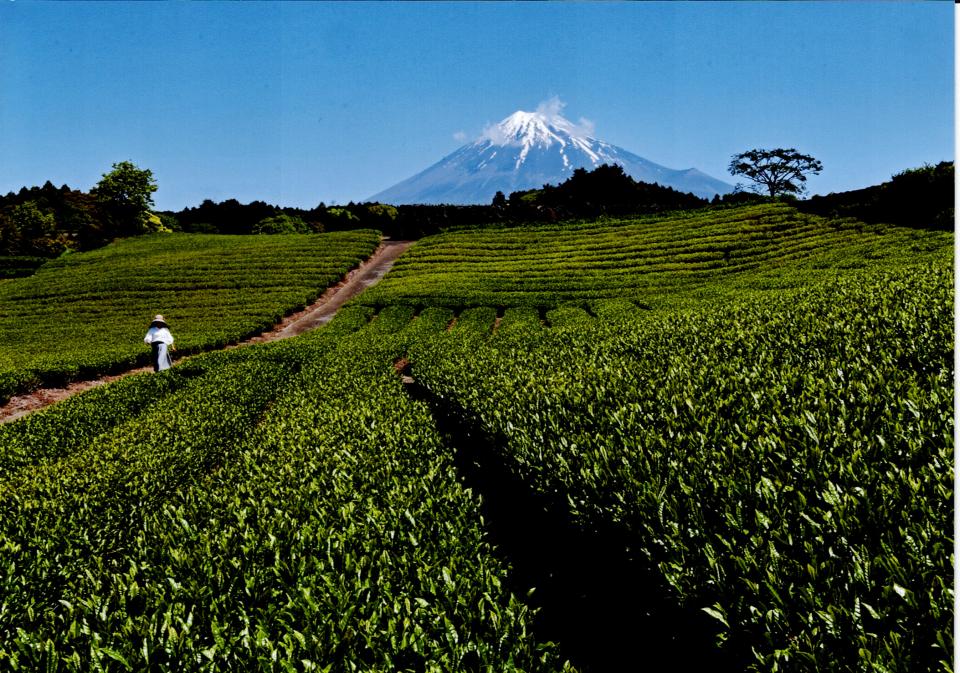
409,262,954,672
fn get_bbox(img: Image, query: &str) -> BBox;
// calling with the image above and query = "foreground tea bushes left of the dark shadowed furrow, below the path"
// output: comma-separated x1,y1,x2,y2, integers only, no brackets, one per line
0,307,569,671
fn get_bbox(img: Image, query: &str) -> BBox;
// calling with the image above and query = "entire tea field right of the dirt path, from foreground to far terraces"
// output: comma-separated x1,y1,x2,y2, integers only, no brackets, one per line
0,205,954,672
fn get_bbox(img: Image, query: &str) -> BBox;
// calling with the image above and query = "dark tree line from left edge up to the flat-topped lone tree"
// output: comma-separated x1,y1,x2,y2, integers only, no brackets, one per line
0,153,808,260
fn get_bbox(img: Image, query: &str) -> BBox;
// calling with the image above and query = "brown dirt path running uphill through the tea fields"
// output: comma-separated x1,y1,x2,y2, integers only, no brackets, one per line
0,240,413,423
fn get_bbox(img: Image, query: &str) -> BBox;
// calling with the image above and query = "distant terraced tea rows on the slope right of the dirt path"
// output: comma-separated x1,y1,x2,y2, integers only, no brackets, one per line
361,204,951,308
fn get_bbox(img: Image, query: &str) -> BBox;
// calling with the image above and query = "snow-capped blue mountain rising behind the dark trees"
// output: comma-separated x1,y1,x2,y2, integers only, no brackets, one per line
368,108,733,205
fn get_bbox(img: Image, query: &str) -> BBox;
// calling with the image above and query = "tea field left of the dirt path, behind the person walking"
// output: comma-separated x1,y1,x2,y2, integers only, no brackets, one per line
0,231,379,402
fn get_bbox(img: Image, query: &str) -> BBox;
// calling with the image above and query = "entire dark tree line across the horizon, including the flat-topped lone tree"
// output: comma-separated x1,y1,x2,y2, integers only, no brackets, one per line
0,154,954,266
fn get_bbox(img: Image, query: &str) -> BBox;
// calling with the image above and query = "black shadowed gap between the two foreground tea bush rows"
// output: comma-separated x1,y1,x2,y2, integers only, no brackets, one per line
405,377,748,673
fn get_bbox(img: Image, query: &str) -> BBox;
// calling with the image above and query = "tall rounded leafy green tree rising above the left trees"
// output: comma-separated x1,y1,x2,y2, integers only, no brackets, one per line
91,161,157,236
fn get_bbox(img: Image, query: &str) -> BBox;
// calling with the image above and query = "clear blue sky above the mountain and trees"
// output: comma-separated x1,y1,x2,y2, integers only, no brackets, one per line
0,1,954,209
